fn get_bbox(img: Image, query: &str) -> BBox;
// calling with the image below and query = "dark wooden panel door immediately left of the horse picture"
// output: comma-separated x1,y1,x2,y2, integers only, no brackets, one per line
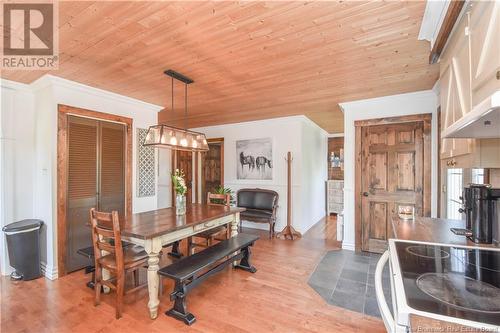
201,140,224,203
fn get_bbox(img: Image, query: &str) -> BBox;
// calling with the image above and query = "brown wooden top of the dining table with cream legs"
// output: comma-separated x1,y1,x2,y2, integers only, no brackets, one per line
121,204,245,239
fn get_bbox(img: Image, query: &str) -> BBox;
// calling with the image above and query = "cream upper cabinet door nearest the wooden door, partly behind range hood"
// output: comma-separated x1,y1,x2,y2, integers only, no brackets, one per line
440,14,472,158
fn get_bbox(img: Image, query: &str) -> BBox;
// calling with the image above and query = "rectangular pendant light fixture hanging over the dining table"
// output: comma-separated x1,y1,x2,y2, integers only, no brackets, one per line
143,69,208,151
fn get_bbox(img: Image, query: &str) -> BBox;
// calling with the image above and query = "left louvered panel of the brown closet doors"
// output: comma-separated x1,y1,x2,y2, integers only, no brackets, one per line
66,116,99,272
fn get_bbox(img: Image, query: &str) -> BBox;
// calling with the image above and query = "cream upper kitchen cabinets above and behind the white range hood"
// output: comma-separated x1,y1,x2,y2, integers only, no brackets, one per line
440,1,500,168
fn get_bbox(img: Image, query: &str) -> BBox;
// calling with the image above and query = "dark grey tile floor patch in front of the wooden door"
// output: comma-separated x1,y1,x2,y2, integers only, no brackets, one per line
308,250,391,317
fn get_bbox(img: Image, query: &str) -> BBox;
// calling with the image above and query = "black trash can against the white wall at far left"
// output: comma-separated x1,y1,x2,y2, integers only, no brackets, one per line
2,220,43,281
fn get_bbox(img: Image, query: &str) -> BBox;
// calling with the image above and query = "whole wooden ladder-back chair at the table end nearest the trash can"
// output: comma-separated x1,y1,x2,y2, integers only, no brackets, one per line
90,208,148,319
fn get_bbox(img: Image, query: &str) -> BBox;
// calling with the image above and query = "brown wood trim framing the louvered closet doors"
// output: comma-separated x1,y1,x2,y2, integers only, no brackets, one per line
57,104,133,277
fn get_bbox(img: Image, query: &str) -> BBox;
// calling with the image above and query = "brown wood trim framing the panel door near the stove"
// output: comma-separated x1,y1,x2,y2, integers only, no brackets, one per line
354,113,432,251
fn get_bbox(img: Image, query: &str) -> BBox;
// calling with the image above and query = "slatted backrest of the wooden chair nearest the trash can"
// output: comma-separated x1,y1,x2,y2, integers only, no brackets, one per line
90,208,124,272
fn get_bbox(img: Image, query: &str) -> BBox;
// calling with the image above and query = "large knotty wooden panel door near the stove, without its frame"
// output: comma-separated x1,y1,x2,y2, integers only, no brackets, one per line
361,122,424,253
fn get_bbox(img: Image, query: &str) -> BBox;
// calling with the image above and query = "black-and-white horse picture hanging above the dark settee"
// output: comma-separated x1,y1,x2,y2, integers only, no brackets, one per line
236,138,273,180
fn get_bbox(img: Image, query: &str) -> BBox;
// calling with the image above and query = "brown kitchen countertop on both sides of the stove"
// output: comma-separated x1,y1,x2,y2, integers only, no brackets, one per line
392,217,494,332
